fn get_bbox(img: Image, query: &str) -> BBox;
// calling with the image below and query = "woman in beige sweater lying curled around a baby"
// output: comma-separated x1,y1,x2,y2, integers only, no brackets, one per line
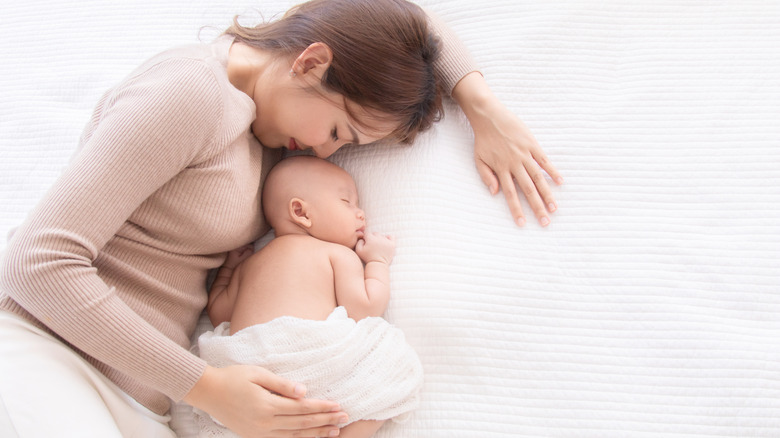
0,0,557,437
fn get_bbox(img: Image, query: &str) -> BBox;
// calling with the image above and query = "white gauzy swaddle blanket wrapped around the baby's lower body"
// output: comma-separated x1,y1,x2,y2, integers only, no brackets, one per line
195,307,423,437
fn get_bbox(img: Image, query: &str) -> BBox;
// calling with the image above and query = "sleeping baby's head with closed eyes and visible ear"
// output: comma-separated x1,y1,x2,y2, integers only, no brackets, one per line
263,155,366,249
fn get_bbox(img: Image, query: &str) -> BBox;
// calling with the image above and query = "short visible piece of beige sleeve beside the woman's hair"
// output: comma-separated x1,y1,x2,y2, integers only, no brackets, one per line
425,9,479,94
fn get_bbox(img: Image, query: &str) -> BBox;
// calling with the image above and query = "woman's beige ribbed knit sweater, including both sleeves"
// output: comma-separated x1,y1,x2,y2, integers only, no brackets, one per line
0,21,475,414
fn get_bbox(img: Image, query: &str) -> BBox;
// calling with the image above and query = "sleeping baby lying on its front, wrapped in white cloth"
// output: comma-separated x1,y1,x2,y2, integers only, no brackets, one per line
196,156,422,437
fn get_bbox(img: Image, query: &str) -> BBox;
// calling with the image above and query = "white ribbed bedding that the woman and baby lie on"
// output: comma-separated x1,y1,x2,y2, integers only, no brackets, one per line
0,0,780,438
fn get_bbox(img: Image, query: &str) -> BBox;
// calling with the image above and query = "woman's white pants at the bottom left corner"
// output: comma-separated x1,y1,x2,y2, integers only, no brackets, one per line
0,311,176,438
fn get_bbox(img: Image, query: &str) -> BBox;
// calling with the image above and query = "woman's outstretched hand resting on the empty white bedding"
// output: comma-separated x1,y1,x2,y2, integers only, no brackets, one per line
452,72,563,226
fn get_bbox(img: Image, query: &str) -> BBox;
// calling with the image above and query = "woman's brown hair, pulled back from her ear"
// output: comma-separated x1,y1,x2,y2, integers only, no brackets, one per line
225,0,442,143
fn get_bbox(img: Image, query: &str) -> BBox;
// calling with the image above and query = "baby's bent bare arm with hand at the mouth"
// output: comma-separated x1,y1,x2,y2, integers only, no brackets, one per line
333,233,395,321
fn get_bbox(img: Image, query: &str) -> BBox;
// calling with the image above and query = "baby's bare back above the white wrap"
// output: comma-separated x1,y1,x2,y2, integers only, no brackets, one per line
229,235,344,333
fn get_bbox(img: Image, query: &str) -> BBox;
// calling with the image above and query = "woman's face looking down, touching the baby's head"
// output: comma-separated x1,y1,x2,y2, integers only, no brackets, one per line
252,81,395,158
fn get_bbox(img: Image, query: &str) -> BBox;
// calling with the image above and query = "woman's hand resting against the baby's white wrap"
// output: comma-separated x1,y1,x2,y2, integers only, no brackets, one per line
184,365,347,438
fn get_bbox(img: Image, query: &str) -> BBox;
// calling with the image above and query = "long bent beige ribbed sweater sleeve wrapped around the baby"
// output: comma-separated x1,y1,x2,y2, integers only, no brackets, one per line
0,58,222,400
